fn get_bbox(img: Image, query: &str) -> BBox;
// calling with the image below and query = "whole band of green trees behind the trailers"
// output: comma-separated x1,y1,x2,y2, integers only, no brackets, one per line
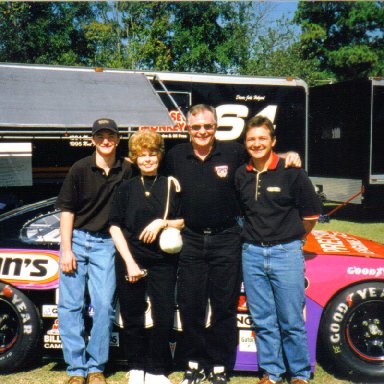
0,1,384,85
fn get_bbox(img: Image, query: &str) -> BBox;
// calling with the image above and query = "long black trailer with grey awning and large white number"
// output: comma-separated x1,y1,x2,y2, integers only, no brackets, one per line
0,64,308,209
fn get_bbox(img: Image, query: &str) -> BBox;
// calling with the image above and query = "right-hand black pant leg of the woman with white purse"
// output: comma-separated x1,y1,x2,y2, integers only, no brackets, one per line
146,255,176,374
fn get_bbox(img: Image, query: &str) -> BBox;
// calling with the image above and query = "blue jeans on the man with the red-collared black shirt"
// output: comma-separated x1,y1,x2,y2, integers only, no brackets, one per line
243,240,311,381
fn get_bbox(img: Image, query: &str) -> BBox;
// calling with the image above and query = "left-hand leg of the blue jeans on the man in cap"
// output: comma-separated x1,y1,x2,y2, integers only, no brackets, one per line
58,230,88,376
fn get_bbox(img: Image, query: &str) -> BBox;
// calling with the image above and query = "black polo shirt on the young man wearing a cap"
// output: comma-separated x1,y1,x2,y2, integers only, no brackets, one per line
56,153,132,232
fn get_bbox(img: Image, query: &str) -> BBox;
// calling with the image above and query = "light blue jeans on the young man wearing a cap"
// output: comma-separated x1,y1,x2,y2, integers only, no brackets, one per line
58,229,116,377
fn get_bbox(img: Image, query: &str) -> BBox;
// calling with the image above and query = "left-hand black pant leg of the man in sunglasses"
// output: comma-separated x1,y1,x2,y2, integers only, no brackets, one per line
177,228,208,364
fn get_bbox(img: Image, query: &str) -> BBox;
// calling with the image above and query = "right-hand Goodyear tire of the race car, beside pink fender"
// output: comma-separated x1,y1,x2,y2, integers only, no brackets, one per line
319,282,384,382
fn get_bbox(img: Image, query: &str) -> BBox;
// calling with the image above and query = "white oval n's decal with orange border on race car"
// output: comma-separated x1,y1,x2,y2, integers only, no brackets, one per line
0,249,59,289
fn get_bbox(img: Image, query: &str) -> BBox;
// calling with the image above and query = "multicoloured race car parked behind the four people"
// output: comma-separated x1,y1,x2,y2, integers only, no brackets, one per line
0,198,384,382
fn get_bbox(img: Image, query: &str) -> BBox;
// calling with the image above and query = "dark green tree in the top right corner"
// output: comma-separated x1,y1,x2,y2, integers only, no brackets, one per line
295,1,384,80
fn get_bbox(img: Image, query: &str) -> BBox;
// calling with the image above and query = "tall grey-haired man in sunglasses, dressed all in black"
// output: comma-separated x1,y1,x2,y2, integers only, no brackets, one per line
167,104,300,384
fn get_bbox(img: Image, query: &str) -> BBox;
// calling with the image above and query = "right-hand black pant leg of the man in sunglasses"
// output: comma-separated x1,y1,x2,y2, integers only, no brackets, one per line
206,226,241,371
